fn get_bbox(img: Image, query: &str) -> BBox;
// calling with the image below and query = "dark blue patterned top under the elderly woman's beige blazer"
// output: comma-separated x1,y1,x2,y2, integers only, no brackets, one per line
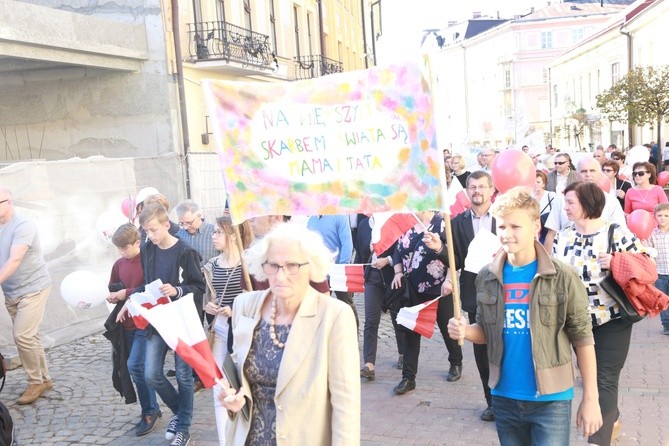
244,319,291,446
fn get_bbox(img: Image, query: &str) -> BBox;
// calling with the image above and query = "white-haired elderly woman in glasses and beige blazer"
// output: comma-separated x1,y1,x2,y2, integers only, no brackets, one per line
219,224,360,446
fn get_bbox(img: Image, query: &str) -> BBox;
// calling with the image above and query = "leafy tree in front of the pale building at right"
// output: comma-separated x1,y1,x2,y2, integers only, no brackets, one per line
597,65,669,172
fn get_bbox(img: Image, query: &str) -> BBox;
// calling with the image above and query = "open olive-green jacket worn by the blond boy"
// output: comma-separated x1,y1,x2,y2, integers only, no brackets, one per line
476,242,595,395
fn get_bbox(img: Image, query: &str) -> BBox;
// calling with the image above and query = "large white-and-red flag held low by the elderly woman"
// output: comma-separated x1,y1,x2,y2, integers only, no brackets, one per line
127,293,223,388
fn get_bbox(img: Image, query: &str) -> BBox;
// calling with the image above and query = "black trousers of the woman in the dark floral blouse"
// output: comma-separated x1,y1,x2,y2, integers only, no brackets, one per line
402,294,462,380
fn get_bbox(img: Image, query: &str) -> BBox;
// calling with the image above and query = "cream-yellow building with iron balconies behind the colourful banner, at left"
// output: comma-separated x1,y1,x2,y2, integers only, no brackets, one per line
174,0,366,214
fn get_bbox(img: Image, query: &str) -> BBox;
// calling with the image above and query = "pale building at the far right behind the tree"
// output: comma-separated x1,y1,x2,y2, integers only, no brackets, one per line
550,0,669,150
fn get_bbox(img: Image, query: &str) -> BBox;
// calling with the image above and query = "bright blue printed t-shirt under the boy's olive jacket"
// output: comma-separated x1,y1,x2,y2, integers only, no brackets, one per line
491,260,574,401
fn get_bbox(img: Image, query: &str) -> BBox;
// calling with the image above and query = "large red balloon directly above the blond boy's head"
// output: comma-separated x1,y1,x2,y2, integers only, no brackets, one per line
492,149,537,193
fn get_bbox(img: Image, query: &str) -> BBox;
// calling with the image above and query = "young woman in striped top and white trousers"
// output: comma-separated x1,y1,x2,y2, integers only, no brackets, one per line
202,215,253,446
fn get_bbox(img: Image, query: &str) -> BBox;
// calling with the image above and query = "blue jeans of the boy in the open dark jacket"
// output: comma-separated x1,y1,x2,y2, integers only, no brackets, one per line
144,331,193,432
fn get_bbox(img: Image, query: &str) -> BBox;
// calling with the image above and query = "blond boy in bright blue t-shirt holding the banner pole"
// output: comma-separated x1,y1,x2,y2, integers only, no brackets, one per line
448,187,602,446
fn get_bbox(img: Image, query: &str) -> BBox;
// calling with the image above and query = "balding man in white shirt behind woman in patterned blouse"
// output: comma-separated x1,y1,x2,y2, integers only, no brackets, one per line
544,158,627,252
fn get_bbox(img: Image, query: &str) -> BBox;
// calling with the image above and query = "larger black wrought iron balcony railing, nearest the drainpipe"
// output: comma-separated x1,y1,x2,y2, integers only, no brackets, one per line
188,21,279,70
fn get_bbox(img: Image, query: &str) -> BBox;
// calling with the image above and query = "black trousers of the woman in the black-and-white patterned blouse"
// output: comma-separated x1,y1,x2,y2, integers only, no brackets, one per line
588,319,632,446
